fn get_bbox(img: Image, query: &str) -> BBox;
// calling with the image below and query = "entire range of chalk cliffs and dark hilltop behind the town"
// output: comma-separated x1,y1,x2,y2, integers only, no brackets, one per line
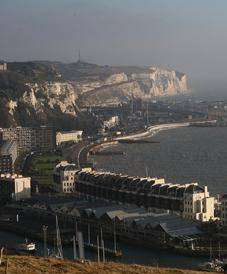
0,62,188,128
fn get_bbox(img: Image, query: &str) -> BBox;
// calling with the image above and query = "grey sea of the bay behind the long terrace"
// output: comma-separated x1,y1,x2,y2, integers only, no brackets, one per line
95,127,227,194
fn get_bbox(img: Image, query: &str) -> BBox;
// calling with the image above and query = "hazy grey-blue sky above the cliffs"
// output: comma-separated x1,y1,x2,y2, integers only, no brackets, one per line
0,0,227,98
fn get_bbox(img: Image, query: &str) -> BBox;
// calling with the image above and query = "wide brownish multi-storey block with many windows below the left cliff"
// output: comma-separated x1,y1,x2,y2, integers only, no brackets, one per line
2,126,56,152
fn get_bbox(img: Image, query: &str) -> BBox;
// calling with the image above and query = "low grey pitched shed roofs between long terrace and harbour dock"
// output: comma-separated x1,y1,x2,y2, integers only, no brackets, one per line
13,197,201,237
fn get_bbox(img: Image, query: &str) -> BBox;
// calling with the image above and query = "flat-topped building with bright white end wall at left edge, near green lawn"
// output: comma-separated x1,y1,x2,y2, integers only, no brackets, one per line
0,174,31,202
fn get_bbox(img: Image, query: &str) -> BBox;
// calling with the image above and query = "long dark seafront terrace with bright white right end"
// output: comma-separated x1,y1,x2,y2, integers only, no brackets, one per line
76,171,214,222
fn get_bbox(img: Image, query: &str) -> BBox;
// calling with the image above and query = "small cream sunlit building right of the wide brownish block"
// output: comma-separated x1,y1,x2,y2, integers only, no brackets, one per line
56,130,83,146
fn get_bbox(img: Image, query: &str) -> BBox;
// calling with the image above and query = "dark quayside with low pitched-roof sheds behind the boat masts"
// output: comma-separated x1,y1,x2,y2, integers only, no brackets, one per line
0,195,222,257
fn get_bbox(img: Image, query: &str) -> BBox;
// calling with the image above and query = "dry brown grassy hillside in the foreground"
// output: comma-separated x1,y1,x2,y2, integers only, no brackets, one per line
0,256,215,274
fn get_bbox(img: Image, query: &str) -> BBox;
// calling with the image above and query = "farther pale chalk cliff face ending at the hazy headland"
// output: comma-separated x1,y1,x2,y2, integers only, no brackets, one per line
78,67,188,106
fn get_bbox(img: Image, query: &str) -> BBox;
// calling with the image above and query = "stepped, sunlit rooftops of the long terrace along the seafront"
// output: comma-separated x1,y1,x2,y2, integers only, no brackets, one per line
77,171,207,198
